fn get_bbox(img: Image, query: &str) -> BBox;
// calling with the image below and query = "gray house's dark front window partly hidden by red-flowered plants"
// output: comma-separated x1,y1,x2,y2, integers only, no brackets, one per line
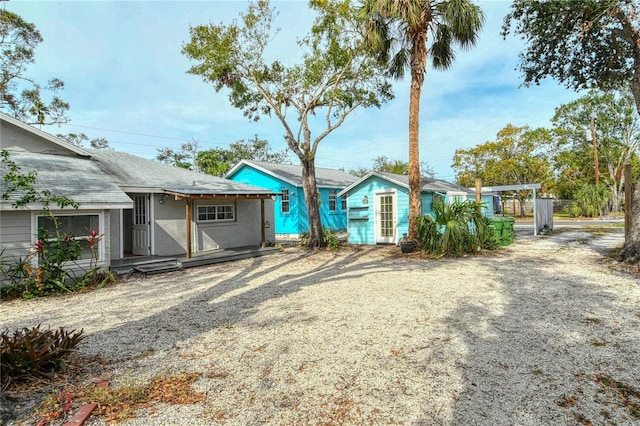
36,213,104,261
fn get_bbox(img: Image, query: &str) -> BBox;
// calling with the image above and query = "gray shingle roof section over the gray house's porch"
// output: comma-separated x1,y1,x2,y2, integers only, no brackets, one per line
88,150,271,195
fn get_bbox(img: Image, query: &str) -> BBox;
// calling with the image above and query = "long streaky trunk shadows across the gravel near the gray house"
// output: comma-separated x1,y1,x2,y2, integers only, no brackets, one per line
82,248,444,362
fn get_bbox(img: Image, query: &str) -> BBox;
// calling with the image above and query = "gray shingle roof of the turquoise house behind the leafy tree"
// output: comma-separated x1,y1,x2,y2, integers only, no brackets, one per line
229,160,358,189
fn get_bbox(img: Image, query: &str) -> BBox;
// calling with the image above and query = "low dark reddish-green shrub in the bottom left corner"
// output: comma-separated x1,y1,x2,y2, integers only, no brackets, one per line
0,325,84,389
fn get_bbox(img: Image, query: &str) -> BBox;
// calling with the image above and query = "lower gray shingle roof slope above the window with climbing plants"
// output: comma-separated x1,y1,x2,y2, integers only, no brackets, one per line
0,151,132,208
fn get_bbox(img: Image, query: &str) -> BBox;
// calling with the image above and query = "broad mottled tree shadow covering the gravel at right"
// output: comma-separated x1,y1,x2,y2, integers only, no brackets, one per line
447,233,640,425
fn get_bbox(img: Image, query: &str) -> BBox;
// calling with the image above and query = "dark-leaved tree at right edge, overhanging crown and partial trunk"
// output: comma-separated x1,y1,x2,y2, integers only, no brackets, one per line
502,0,640,262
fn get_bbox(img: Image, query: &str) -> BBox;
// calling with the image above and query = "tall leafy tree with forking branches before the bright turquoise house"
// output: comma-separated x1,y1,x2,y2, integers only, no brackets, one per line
183,0,393,247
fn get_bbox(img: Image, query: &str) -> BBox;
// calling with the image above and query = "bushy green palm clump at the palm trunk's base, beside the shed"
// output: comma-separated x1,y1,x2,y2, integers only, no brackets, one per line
416,199,496,255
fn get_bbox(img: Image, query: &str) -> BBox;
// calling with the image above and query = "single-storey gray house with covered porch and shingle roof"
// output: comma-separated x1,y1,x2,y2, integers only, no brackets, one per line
0,114,276,267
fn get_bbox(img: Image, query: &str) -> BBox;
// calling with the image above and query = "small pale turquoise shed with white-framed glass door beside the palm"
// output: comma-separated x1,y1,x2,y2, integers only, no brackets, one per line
338,172,493,245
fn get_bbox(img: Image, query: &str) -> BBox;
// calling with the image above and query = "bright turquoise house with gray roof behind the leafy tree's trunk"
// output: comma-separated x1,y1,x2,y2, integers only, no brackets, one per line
226,160,358,238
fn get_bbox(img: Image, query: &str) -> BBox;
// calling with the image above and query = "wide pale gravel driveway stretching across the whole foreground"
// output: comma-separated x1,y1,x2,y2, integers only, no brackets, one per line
0,228,640,425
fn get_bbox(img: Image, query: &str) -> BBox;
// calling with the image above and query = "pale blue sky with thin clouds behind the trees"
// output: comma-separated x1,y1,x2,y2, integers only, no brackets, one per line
0,0,579,181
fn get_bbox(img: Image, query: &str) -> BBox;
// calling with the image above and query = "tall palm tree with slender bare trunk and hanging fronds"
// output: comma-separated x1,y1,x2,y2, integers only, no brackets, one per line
360,0,484,238
